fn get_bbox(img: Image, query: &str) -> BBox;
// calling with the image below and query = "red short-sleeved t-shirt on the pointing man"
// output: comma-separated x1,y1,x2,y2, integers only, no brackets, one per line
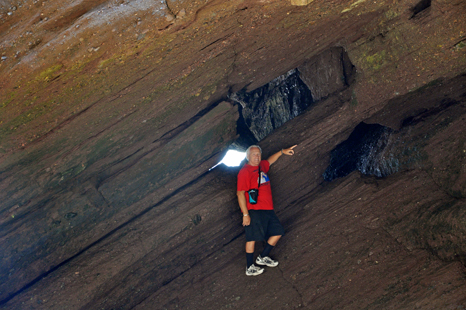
237,160,273,210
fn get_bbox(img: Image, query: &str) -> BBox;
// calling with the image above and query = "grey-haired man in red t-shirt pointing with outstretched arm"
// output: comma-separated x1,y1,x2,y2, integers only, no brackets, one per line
236,145,296,276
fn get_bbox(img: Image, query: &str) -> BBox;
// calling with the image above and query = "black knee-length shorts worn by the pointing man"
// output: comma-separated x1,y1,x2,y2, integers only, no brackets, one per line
244,210,285,242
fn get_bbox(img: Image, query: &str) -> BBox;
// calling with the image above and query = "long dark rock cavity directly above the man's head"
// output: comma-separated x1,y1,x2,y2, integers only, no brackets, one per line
230,47,356,141
